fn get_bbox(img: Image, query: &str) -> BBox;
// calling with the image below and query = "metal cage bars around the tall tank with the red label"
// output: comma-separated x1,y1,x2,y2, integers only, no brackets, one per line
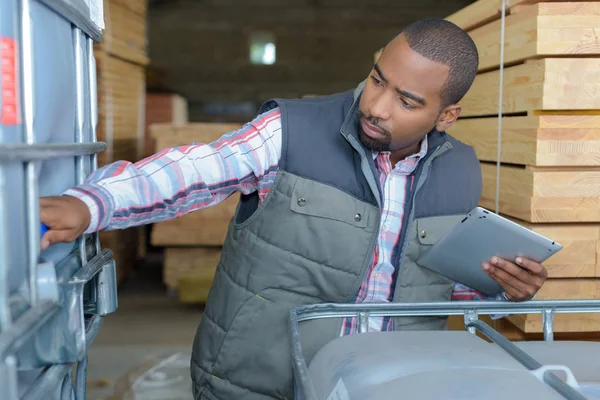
0,0,118,400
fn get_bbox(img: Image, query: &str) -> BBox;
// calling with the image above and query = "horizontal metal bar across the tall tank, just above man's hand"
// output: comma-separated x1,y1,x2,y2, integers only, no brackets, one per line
0,142,107,163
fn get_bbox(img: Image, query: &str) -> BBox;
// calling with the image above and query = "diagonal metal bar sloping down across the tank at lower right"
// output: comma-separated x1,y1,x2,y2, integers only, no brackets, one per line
469,321,585,400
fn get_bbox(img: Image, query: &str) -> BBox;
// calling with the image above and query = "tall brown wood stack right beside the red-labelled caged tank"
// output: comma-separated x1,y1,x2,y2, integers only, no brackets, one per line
94,0,149,281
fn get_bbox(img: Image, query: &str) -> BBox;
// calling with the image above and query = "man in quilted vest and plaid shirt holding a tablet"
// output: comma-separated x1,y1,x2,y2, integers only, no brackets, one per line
41,19,547,400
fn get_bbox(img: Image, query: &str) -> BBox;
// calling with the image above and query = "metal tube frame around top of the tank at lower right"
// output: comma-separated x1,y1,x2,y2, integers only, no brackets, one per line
289,299,600,400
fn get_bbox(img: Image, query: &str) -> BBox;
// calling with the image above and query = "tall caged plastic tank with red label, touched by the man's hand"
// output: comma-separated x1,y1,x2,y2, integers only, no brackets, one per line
0,0,117,400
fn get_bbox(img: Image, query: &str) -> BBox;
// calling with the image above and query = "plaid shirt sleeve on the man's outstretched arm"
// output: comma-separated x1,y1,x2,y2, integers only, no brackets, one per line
63,108,281,233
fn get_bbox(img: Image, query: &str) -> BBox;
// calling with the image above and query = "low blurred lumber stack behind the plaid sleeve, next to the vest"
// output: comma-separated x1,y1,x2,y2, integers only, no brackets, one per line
150,123,241,303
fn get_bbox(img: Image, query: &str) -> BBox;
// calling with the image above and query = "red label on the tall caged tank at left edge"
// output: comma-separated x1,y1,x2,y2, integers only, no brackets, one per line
0,37,19,125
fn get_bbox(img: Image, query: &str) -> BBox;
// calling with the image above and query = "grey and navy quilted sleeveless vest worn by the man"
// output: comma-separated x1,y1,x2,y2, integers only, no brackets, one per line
191,86,481,400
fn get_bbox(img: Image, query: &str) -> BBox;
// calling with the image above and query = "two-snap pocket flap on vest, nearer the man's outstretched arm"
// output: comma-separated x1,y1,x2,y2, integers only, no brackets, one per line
290,178,376,228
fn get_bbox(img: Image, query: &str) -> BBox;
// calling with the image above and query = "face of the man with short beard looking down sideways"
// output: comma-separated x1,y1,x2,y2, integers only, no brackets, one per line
359,35,460,158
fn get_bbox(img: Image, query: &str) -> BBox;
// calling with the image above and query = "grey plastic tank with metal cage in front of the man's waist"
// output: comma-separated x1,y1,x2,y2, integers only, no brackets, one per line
289,300,600,400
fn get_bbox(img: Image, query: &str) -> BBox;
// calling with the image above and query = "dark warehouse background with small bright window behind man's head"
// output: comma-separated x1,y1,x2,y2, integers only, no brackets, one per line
148,0,470,121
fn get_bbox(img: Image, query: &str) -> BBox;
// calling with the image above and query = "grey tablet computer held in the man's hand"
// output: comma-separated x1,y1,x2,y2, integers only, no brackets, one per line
417,207,562,296
